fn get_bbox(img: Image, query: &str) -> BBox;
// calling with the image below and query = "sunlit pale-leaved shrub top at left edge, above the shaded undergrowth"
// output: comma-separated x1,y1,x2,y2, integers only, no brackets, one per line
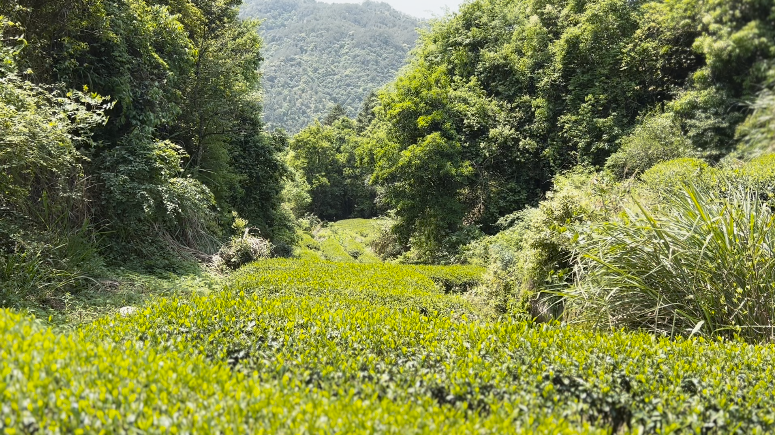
0,47,110,226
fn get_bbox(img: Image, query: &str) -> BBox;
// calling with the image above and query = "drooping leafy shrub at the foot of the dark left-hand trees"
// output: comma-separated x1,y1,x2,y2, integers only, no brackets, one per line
98,135,220,270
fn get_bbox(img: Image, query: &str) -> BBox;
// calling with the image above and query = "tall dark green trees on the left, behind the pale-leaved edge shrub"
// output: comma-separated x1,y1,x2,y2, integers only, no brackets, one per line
0,0,292,268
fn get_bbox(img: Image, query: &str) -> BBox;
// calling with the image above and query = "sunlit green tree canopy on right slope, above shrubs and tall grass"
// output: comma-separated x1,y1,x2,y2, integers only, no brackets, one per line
348,0,775,256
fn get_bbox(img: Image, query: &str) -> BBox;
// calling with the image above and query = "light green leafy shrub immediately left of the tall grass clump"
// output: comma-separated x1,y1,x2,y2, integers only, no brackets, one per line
466,168,625,320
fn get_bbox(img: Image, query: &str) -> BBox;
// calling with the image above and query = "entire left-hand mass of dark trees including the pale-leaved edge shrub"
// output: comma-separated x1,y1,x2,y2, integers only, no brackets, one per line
0,0,292,280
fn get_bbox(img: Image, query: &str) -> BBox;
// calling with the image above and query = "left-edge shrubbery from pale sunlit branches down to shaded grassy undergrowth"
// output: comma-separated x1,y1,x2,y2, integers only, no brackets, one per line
0,23,111,307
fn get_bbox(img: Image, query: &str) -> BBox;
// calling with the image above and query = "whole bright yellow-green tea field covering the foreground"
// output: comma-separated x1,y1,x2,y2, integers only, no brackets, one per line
0,259,775,434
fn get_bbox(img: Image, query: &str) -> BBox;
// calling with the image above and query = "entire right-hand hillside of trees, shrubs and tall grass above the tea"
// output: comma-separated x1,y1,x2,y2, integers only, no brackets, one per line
276,0,775,341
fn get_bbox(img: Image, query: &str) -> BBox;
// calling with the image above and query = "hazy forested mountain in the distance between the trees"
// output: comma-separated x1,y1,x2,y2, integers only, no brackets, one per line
240,0,423,133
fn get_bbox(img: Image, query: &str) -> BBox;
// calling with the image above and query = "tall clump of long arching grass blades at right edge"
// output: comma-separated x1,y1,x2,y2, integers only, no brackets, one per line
567,181,775,341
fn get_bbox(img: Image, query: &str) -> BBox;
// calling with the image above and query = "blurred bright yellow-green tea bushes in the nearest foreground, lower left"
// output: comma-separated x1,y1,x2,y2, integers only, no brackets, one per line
0,311,540,434
